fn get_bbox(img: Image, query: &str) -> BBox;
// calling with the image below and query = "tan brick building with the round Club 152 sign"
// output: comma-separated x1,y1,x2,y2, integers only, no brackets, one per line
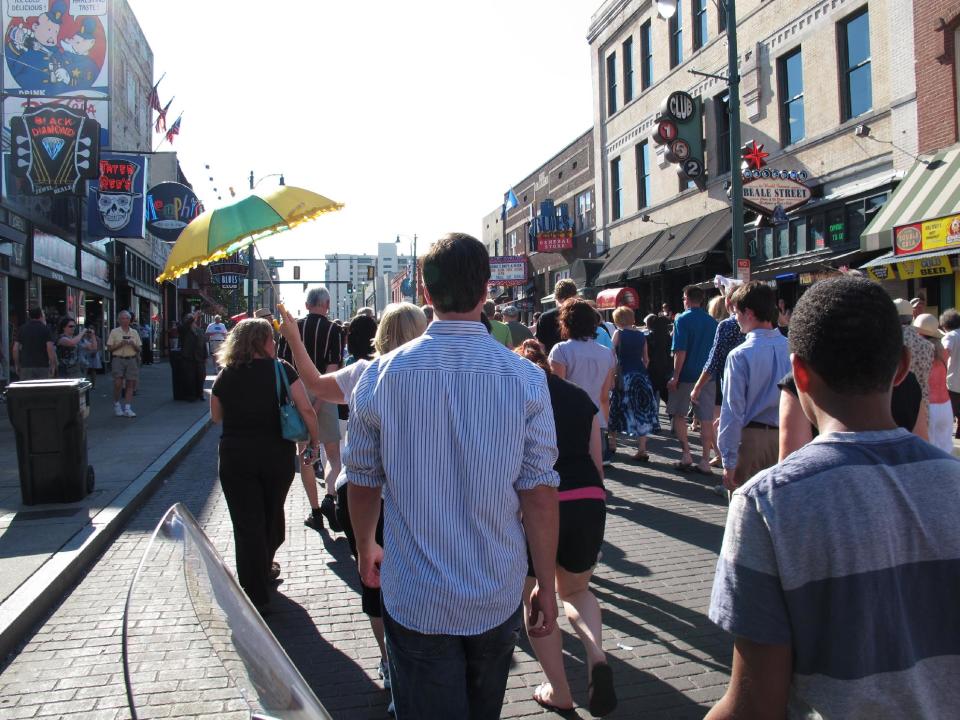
588,0,917,310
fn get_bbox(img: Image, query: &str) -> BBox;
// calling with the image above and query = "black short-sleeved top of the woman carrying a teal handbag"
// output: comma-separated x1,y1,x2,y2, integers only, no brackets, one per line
213,358,300,444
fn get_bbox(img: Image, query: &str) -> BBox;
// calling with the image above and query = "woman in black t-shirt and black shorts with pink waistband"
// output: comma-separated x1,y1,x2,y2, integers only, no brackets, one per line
517,340,617,717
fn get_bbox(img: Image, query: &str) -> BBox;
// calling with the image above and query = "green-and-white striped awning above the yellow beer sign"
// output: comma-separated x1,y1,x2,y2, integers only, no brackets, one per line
860,145,960,251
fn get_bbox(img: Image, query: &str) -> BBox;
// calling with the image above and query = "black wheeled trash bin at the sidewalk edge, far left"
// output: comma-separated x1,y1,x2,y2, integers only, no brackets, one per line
7,380,94,505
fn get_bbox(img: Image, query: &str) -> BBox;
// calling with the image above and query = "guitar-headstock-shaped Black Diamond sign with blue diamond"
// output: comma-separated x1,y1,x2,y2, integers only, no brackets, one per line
10,105,100,195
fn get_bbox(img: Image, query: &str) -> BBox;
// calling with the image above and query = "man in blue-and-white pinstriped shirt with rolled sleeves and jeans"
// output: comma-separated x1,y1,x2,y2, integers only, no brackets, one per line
346,234,560,720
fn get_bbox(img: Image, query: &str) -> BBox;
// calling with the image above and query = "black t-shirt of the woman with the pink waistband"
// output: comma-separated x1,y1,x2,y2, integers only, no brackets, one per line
547,374,603,490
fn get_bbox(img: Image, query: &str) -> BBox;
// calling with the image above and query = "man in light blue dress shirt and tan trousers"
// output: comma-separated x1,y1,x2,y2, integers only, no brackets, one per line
717,280,790,492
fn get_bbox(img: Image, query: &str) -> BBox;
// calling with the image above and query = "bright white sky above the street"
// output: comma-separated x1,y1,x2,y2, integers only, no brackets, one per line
128,0,602,307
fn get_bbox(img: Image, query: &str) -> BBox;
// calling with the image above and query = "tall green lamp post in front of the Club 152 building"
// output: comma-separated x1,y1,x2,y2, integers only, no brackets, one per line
656,0,744,276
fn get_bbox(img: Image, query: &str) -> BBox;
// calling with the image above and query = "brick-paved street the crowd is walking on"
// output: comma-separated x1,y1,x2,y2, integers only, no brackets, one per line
0,416,731,720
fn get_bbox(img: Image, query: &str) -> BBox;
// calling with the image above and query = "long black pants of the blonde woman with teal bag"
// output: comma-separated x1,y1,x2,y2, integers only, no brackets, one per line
220,438,296,605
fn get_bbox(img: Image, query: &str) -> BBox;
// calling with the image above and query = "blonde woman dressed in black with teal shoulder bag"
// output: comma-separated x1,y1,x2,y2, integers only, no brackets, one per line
210,318,319,612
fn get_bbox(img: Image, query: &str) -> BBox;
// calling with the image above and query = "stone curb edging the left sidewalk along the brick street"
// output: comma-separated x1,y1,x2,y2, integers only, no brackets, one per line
0,412,211,664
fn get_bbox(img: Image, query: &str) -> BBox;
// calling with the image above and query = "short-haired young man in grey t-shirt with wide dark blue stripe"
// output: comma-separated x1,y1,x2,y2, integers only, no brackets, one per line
707,277,960,720
